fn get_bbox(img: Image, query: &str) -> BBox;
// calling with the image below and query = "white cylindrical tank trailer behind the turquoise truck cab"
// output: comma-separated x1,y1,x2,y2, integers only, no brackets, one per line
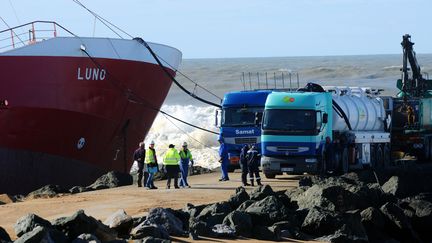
323,87,391,171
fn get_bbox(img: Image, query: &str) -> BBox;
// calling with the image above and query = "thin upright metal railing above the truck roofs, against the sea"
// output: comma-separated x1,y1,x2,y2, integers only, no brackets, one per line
240,70,300,90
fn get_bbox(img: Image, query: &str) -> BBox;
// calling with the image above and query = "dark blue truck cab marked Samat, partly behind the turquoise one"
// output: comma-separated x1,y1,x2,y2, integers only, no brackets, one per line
216,90,272,172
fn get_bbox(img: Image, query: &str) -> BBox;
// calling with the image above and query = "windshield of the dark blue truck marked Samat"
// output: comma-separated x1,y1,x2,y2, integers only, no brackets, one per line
222,107,263,127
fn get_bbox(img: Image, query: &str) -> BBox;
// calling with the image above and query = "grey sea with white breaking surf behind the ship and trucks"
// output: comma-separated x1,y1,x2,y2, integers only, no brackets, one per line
135,54,432,169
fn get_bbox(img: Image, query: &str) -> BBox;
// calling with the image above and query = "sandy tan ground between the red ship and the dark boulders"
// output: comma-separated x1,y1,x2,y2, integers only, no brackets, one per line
0,172,304,242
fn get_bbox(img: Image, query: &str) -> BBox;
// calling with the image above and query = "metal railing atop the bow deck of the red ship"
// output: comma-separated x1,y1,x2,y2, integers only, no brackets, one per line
0,20,76,52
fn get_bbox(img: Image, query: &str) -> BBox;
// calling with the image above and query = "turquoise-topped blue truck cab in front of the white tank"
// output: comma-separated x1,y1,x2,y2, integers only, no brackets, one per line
261,91,332,178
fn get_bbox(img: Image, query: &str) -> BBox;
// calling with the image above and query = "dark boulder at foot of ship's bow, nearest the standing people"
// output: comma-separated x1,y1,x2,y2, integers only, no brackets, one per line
87,171,133,190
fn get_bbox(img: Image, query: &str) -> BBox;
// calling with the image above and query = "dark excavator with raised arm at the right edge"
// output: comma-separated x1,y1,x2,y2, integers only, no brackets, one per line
386,34,432,162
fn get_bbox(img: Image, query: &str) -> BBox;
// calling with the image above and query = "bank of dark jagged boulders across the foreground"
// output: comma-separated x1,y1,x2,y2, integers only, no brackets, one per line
0,168,432,242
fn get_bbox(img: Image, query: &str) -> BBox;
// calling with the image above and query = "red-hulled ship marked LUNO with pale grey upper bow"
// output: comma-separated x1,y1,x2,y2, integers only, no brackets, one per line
0,21,182,194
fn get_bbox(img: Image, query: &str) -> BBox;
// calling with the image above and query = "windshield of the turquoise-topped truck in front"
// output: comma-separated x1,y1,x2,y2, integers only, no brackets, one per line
262,110,317,135
